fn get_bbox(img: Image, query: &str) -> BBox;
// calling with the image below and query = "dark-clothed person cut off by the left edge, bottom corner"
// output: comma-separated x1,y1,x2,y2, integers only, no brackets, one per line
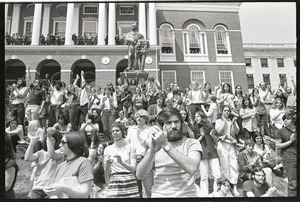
4,133,19,199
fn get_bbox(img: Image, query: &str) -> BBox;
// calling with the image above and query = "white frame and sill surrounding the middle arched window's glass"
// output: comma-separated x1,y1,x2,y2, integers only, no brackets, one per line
182,24,209,62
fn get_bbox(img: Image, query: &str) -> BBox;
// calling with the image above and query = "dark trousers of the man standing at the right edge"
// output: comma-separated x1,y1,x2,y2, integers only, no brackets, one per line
283,159,297,197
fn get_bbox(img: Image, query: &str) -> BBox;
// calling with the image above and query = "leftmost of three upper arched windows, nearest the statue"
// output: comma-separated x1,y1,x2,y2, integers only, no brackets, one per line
159,24,175,54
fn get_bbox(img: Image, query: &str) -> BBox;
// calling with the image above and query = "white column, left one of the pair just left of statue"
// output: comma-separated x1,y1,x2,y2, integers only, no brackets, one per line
98,3,107,45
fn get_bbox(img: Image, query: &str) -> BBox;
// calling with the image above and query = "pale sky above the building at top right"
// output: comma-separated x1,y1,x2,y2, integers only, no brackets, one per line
239,2,296,43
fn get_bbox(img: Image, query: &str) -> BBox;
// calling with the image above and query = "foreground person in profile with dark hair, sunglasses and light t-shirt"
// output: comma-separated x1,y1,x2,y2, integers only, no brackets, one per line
44,132,94,198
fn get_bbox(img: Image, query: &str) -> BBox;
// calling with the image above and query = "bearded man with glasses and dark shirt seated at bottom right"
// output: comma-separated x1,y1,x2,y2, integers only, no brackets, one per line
243,168,277,197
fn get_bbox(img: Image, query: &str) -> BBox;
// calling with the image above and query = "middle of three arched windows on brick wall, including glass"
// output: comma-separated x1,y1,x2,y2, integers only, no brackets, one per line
183,24,207,55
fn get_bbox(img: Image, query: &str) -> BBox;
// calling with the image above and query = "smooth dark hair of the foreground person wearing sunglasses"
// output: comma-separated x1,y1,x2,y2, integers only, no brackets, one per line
65,131,89,158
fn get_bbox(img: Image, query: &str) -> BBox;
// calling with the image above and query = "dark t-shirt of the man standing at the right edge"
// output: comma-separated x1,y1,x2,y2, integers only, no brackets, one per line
275,127,297,160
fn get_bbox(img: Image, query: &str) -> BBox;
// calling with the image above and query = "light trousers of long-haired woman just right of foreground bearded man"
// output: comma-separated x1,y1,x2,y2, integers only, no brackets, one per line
199,158,221,197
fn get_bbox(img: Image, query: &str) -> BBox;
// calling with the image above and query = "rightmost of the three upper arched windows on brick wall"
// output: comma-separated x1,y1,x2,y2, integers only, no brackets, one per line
215,25,230,55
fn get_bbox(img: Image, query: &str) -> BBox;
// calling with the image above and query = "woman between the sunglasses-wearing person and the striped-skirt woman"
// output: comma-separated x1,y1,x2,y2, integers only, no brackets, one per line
88,143,107,188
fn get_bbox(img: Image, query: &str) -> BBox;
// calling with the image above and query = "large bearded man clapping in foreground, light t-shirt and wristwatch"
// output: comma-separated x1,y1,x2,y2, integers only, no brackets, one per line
136,107,202,198
